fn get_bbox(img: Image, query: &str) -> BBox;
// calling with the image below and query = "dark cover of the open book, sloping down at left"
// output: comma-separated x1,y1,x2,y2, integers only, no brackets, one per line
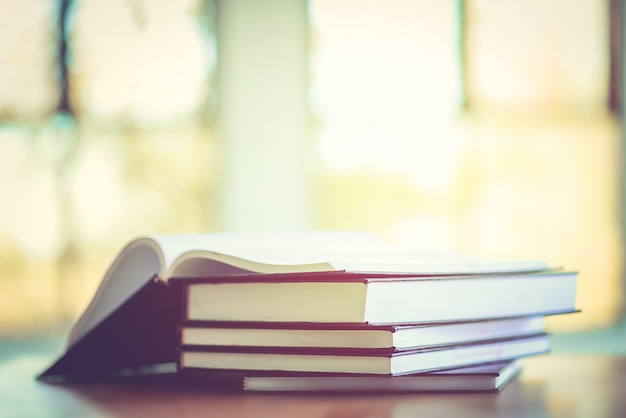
38,280,182,381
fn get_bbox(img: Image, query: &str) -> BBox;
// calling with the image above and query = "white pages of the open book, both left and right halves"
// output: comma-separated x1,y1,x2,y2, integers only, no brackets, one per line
68,231,549,347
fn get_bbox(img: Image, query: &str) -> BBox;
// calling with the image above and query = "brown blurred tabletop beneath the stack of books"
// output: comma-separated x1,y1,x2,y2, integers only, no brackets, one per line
0,353,626,418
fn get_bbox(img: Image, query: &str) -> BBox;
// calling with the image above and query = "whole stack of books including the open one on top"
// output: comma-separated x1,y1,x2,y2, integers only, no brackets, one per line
40,232,577,393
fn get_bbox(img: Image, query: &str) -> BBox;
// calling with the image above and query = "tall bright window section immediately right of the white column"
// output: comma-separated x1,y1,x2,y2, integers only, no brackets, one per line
311,0,461,255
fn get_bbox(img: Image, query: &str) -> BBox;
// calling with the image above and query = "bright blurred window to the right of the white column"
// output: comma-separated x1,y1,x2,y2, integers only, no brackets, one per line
311,0,623,331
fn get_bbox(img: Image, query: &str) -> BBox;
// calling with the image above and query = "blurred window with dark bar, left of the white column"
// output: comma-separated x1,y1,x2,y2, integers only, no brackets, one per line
0,0,217,333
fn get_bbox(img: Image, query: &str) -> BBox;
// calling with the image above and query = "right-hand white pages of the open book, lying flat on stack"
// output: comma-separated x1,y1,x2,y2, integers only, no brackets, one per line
153,231,549,278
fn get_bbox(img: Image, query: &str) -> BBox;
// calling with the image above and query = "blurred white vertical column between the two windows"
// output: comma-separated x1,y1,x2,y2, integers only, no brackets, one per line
215,0,311,231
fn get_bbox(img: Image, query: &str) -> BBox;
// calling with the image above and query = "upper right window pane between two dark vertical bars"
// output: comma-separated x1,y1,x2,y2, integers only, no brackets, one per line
466,0,609,113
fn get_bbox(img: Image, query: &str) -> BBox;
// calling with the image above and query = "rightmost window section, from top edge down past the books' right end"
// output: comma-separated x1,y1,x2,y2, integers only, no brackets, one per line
466,0,623,329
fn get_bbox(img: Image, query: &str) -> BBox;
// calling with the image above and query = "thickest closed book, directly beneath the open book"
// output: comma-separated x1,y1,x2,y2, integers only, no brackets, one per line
179,270,577,324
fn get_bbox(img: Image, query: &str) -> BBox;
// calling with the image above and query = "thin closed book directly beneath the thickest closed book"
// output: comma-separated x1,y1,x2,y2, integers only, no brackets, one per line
180,316,544,350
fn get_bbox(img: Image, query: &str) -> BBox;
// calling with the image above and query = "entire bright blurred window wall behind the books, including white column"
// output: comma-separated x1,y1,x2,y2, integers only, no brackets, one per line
0,0,624,337
